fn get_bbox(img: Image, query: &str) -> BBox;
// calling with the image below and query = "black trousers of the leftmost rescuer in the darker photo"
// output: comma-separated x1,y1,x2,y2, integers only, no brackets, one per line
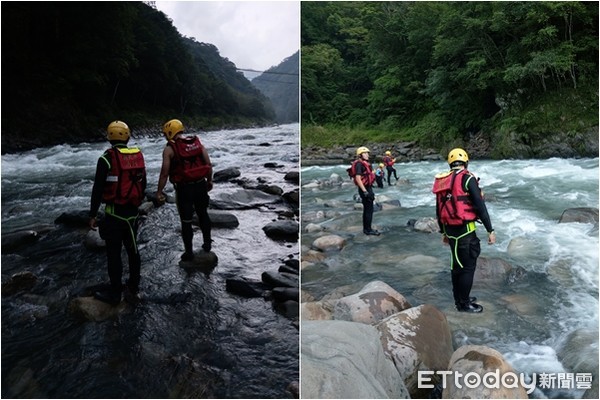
99,214,142,293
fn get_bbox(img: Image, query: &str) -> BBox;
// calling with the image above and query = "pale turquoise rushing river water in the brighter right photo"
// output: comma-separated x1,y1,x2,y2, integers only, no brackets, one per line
301,158,599,398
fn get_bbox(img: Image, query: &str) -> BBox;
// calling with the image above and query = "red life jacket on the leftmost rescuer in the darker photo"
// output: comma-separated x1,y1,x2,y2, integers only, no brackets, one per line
102,147,146,207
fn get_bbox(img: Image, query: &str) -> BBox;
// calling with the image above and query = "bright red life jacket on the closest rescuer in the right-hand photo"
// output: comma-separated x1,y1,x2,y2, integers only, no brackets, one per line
432,169,477,225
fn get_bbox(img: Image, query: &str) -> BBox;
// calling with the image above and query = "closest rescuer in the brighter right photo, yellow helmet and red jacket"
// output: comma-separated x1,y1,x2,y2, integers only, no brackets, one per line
432,148,496,313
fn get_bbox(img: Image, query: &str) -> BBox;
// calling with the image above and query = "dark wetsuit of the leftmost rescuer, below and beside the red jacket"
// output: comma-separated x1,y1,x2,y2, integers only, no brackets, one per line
90,145,146,302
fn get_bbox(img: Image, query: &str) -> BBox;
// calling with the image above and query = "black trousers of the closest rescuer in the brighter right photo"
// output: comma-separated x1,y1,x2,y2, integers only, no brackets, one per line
448,231,481,305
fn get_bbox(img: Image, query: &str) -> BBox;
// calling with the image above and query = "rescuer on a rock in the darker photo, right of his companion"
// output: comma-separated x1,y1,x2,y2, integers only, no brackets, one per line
156,119,213,261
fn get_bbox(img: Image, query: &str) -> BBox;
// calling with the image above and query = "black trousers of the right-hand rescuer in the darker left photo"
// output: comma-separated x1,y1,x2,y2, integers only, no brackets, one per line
175,180,211,253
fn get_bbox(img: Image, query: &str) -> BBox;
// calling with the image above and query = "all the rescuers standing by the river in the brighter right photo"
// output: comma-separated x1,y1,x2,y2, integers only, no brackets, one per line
348,146,496,313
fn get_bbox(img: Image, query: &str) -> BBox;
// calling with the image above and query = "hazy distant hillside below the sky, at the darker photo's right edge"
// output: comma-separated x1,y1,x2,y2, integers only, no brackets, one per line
252,51,300,123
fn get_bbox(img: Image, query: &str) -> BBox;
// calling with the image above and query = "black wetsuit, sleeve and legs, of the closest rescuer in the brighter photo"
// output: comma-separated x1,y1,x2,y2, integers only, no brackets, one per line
436,174,493,307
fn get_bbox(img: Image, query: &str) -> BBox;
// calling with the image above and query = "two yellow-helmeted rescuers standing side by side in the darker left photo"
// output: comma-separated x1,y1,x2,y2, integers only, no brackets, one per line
89,119,213,305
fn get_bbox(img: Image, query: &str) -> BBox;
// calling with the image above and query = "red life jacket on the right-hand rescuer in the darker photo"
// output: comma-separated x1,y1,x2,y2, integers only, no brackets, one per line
168,136,212,183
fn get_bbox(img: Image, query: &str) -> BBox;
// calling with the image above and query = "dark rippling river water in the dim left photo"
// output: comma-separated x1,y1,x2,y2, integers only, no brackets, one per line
1,124,299,398
